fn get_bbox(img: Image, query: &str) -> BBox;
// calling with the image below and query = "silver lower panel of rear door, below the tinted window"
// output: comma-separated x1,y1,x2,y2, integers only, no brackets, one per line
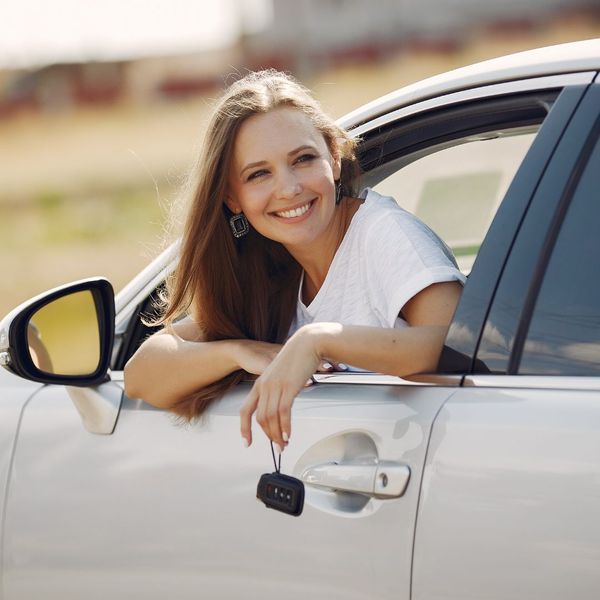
413,384,600,600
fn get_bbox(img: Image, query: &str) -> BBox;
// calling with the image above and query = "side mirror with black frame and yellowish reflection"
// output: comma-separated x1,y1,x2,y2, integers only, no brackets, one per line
0,277,115,387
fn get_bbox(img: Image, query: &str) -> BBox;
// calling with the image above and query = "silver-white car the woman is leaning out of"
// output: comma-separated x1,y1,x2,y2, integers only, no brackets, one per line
0,40,600,600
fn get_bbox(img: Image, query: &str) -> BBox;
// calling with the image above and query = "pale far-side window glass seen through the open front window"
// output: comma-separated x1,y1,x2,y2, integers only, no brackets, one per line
375,131,538,274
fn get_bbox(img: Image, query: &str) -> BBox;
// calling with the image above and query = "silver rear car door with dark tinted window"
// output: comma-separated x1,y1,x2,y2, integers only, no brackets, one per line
413,77,600,600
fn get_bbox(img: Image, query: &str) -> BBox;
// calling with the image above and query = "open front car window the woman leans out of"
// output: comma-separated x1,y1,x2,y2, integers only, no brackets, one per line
113,90,560,369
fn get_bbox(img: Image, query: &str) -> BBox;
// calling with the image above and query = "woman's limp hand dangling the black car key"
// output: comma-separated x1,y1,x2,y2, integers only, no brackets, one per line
240,324,326,449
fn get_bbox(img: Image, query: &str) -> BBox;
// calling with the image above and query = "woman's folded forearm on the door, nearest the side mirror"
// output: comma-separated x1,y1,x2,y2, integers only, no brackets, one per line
124,318,280,409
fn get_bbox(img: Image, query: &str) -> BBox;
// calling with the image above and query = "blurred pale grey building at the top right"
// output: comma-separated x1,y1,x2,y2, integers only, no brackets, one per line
246,0,600,72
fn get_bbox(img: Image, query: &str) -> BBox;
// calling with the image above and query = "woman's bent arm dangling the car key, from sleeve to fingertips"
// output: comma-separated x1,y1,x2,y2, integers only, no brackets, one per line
241,282,462,448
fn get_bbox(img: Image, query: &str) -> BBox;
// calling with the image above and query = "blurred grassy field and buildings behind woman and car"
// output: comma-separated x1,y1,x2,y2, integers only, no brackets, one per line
0,0,600,315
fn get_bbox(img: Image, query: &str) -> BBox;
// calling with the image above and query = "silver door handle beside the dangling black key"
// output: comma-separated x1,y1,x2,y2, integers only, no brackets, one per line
300,461,410,498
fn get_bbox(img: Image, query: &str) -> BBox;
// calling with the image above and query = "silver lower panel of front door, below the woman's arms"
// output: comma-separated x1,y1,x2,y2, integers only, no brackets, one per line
4,378,454,600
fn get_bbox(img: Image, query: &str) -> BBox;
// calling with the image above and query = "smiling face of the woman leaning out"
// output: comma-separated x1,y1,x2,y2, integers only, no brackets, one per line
227,107,340,250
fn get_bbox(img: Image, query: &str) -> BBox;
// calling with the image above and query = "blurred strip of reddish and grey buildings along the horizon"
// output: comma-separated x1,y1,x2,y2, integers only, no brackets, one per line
0,0,600,118
